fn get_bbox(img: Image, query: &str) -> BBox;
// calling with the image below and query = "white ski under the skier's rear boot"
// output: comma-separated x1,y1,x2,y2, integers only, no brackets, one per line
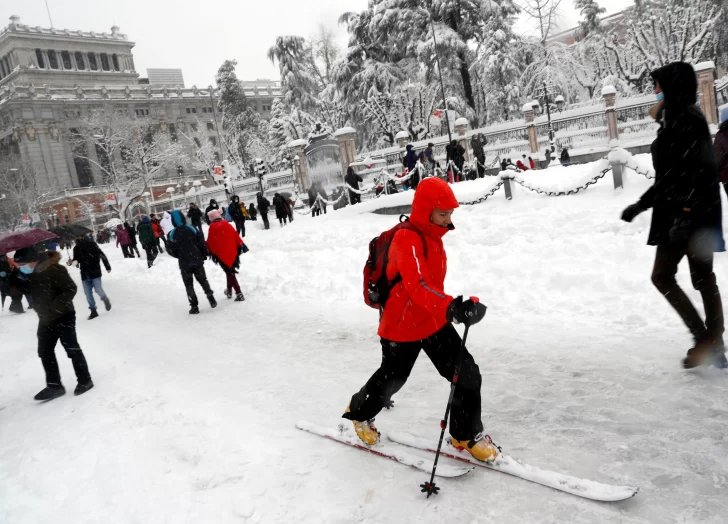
296,422,475,478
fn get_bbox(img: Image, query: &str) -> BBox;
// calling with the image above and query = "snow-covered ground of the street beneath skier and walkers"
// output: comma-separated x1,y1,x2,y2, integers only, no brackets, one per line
0,157,728,524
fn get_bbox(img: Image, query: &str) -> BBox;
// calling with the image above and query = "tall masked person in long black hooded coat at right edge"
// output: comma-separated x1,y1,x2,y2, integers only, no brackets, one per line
622,62,725,369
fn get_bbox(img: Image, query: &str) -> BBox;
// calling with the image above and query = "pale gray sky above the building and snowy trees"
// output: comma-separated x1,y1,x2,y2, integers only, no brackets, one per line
0,0,632,87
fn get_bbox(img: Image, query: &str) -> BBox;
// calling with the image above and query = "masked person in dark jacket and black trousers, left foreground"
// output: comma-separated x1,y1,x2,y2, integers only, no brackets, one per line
14,247,94,401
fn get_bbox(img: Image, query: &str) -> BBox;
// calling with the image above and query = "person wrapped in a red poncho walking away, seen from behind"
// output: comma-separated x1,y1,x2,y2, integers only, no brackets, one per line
207,209,247,302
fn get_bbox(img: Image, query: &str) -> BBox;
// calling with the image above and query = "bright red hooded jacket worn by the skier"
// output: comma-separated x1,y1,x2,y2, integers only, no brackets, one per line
378,178,459,342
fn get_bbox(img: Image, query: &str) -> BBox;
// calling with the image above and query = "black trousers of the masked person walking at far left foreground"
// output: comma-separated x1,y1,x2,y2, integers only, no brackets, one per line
38,312,91,386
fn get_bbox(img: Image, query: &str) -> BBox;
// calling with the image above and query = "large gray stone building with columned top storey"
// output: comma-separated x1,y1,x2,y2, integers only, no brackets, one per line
0,16,225,225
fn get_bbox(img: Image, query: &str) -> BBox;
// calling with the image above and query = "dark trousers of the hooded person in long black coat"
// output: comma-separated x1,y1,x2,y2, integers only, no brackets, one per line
652,246,725,340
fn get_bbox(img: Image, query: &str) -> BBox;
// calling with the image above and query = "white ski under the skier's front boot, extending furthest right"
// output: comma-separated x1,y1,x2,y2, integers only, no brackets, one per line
387,431,639,502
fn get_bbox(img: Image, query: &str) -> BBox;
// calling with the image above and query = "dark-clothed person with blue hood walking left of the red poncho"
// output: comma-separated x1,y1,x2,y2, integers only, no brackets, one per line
167,210,217,315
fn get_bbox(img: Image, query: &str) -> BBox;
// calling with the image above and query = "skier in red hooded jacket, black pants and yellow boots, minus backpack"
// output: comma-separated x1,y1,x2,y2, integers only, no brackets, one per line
343,178,498,461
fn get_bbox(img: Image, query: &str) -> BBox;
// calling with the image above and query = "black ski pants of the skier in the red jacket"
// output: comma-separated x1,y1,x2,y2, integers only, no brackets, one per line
344,323,483,440
